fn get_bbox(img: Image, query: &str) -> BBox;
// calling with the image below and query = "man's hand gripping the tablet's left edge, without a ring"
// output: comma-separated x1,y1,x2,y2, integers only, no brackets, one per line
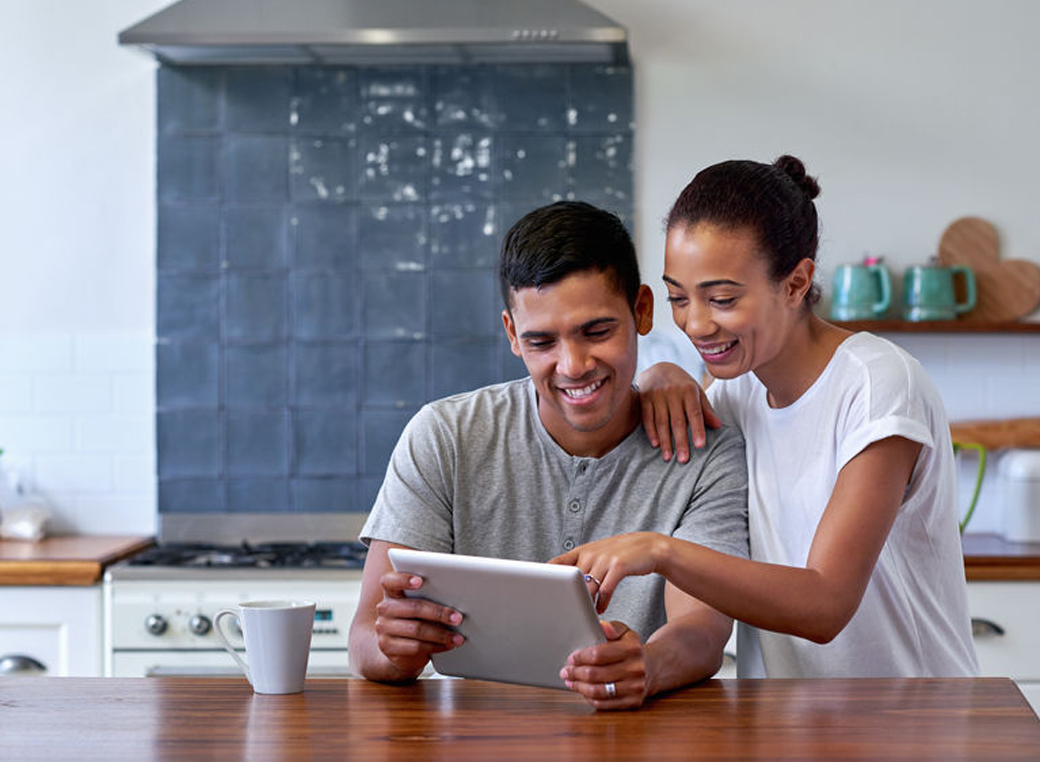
375,572,465,673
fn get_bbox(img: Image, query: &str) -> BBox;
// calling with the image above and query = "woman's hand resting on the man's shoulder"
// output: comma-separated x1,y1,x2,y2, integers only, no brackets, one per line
636,363,722,463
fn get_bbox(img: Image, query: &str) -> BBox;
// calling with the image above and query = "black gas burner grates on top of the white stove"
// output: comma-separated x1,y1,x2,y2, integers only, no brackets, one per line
128,543,367,569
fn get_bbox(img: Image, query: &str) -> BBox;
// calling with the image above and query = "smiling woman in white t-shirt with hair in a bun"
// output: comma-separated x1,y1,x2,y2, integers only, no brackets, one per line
555,156,978,677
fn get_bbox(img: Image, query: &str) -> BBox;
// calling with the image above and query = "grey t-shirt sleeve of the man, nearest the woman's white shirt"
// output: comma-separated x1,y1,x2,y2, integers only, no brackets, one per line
673,426,750,558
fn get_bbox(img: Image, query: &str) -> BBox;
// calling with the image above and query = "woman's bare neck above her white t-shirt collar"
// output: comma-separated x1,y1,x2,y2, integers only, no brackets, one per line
754,312,852,408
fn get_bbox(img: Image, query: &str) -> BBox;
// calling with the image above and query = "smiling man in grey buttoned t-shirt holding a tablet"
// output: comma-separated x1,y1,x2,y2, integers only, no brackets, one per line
349,202,748,709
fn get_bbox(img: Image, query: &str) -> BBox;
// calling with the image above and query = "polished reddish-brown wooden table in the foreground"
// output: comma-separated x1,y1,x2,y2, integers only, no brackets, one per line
0,678,1040,762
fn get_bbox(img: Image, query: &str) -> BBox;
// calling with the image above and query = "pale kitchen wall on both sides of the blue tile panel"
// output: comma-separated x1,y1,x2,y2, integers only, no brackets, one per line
0,0,1040,748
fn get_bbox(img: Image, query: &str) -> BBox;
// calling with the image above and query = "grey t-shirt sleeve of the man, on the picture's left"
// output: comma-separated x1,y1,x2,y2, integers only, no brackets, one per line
360,405,454,552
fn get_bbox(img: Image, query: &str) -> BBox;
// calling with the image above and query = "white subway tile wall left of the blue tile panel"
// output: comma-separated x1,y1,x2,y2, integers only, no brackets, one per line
0,333,156,534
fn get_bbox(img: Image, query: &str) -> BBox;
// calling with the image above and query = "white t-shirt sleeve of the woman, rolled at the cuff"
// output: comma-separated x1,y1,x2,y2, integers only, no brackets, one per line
837,352,937,469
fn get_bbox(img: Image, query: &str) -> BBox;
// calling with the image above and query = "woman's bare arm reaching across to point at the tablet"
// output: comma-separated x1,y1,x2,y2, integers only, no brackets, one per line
554,437,921,642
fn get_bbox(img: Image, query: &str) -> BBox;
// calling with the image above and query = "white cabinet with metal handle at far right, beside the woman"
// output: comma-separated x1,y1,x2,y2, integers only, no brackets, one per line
968,581,1040,714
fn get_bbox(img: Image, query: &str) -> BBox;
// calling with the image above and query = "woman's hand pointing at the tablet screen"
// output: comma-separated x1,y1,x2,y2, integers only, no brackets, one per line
549,532,672,613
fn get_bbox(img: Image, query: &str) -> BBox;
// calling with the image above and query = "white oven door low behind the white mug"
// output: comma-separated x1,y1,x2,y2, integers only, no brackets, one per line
111,650,357,679
